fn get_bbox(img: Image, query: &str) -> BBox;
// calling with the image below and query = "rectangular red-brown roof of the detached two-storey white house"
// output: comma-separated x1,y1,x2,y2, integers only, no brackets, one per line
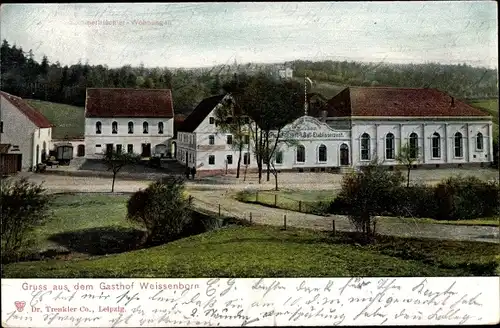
85,88,174,118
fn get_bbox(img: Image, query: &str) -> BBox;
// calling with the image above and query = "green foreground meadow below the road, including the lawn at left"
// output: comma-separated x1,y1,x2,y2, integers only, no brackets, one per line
3,195,500,278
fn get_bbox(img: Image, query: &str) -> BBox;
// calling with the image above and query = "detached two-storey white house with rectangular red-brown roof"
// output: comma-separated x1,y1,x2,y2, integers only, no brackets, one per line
85,88,174,159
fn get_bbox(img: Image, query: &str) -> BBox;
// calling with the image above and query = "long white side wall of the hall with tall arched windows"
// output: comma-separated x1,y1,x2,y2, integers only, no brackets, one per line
352,119,493,166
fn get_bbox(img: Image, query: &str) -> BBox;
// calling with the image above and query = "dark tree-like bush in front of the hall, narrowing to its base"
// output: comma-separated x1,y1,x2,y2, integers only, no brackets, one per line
339,164,404,238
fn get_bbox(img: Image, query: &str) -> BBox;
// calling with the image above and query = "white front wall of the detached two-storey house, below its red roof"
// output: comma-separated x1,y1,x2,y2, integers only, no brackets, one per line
85,118,174,158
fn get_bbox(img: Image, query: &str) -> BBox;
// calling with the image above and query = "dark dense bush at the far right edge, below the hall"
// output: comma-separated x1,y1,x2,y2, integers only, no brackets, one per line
432,177,500,220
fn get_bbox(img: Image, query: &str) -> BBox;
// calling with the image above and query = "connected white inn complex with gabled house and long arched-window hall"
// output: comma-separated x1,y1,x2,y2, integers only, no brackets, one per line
177,87,493,173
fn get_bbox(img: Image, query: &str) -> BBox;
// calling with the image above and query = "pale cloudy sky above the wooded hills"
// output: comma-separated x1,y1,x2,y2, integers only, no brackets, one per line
0,1,498,68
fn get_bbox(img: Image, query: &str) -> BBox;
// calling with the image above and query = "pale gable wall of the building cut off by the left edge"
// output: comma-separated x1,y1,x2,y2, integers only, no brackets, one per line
0,96,38,171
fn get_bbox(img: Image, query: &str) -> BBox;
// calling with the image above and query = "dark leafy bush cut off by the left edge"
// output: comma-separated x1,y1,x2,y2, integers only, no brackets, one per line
0,179,50,263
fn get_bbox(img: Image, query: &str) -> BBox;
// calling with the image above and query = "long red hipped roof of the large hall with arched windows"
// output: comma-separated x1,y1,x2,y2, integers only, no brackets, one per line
326,87,489,117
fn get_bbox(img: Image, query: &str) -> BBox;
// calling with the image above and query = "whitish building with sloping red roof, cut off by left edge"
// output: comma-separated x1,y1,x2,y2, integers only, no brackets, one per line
0,91,53,173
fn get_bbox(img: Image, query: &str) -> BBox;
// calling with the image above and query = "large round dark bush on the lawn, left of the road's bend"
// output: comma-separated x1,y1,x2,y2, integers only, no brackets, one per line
127,177,191,245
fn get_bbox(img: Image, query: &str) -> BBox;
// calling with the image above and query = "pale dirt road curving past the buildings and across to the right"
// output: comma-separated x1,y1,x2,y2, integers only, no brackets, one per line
11,173,499,243
